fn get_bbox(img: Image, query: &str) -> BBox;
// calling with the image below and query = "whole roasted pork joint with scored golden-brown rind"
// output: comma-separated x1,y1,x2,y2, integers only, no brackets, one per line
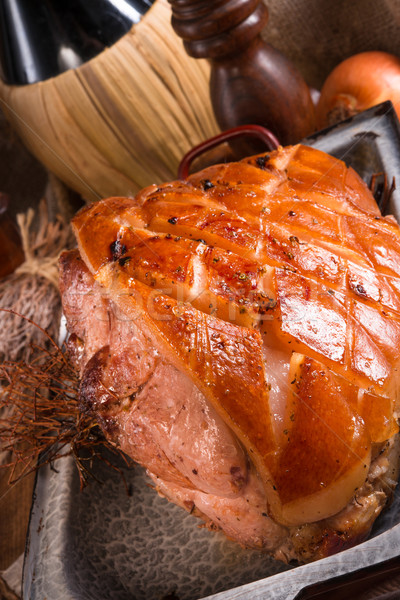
60,145,400,562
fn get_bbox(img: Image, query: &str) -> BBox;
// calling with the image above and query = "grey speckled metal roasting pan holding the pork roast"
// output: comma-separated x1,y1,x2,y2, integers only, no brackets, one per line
23,102,400,600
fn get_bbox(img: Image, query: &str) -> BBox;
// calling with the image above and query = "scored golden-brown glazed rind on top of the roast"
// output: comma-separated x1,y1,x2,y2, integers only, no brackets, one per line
64,146,400,553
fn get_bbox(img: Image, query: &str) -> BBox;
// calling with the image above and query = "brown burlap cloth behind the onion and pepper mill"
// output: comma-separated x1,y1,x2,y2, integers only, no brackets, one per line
263,0,400,89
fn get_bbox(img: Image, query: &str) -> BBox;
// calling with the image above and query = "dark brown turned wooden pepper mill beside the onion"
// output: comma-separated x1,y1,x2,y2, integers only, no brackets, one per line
169,0,314,145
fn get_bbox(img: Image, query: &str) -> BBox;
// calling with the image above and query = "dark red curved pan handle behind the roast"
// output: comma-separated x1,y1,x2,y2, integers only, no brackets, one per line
178,125,280,179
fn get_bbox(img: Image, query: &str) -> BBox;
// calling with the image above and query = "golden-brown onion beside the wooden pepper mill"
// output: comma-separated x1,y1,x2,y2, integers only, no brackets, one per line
316,51,400,129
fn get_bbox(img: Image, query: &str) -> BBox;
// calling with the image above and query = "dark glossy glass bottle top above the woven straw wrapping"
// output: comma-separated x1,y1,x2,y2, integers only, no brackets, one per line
0,0,154,85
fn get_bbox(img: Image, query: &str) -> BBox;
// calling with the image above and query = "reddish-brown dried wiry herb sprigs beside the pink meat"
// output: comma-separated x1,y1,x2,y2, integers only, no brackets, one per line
0,314,127,489
